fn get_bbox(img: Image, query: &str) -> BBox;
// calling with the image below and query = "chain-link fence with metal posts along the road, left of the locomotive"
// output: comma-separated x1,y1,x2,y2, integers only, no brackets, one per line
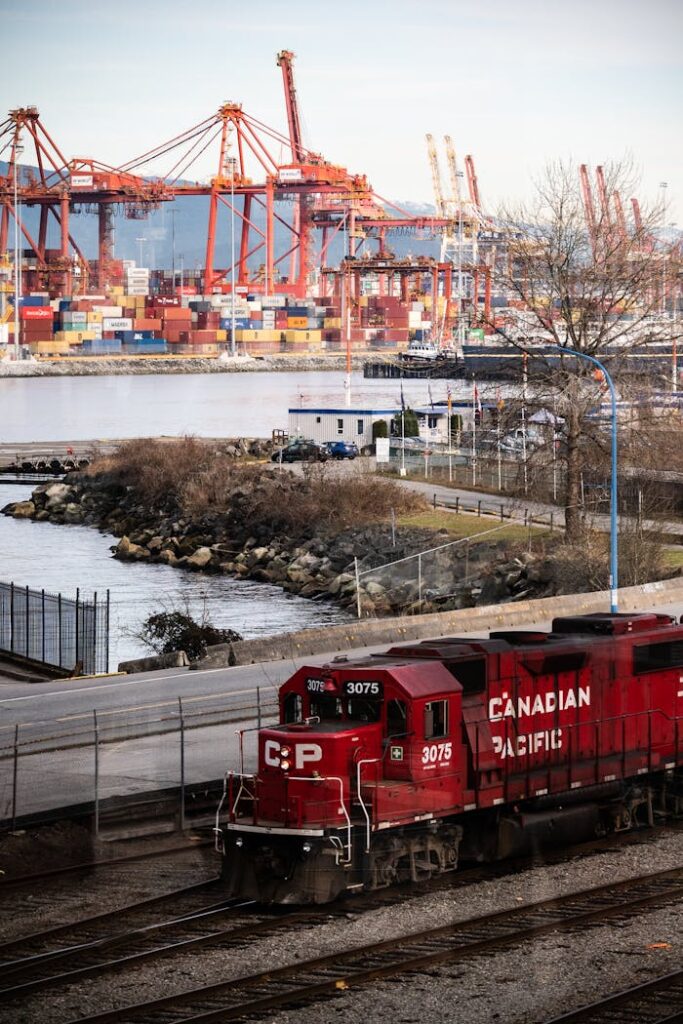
0,687,278,833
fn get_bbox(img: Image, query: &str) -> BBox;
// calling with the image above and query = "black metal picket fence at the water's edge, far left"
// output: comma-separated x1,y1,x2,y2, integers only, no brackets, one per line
0,583,110,675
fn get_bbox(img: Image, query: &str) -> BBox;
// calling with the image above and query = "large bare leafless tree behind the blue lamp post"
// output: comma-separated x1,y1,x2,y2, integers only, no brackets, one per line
483,161,681,542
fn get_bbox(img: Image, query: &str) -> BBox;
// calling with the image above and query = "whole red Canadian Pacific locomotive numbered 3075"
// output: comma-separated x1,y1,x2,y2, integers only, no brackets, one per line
216,613,683,903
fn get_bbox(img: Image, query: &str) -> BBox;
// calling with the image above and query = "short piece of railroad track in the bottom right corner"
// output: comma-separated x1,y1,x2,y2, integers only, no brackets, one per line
546,971,683,1024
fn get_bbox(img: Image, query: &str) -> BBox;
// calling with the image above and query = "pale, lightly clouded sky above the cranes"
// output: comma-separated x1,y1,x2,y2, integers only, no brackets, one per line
0,0,683,227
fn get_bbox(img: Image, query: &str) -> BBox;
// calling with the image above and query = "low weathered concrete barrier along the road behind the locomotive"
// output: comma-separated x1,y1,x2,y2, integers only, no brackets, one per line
190,577,683,669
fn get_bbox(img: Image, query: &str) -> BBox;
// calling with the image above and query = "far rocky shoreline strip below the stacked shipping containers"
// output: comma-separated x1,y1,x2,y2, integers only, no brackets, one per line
0,354,365,378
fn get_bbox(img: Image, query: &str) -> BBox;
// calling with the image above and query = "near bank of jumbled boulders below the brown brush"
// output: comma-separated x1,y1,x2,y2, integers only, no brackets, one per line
2,450,573,616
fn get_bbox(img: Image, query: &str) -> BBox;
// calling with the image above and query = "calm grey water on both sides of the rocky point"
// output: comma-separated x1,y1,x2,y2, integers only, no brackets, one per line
0,372,463,668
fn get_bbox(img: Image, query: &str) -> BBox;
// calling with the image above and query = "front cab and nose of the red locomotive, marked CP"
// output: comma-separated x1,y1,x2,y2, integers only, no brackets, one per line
218,657,463,903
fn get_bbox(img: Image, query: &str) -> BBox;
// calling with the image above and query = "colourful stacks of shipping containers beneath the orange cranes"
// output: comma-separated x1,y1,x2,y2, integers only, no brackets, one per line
3,280,442,355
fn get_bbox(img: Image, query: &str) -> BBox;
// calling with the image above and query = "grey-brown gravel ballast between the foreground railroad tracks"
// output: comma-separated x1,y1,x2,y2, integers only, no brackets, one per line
0,834,683,1024
